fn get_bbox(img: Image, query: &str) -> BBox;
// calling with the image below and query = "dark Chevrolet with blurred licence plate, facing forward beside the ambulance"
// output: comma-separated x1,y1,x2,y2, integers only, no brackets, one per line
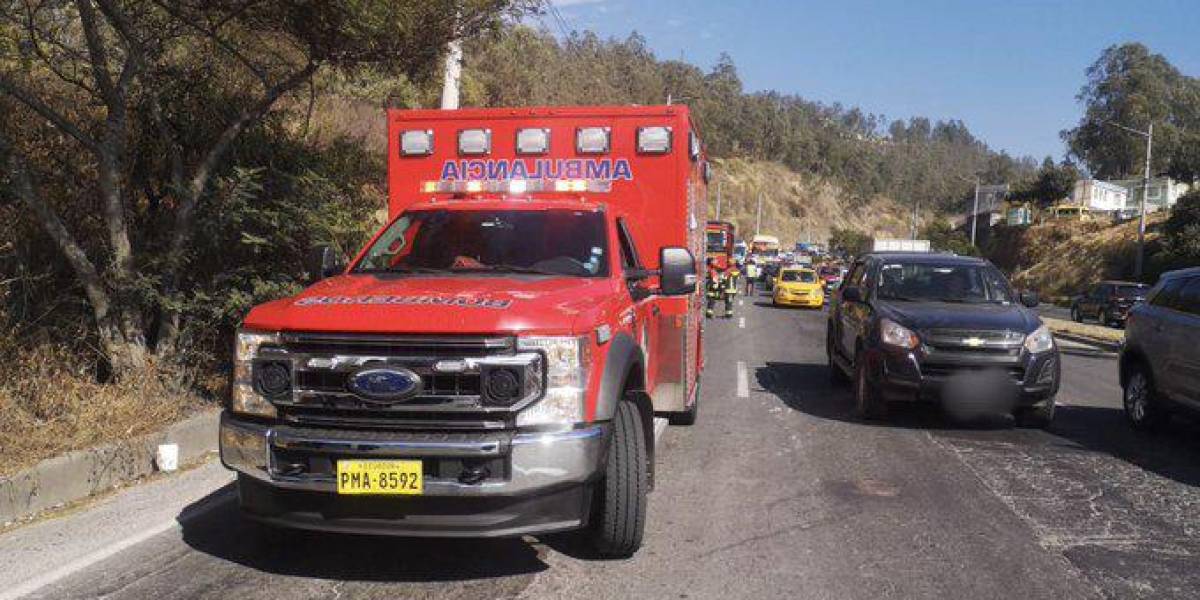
826,252,1060,427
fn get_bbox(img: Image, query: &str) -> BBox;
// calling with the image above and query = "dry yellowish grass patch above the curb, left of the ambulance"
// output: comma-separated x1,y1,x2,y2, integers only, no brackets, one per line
0,335,204,475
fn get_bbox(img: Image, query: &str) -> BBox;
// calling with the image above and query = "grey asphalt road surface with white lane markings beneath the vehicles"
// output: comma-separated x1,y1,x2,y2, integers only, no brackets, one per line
0,299,1200,600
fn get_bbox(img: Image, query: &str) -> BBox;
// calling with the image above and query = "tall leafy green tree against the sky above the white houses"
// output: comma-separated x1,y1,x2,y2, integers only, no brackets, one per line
1062,43,1200,181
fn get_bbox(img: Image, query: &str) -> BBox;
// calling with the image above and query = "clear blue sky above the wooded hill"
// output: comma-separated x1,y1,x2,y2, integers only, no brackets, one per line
541,0,1200,160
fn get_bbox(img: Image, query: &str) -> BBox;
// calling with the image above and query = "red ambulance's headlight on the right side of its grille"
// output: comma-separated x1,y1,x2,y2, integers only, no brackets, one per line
517,337,592,427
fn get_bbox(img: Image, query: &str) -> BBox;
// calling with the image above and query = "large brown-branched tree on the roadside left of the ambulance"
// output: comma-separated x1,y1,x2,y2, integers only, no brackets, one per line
0,0,533,374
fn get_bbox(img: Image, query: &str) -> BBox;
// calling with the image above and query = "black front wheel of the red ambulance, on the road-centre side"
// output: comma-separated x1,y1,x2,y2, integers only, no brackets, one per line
589,401,649,558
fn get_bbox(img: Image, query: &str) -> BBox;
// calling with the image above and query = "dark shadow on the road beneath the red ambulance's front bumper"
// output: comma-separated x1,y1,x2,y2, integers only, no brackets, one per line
178,484,548,582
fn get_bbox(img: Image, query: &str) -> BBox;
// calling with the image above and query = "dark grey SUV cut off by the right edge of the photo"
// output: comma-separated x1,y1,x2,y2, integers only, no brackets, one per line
1121,268,1200,430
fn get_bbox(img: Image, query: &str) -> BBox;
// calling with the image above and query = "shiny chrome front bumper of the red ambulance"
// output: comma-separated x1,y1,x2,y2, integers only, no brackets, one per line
220,413,610,498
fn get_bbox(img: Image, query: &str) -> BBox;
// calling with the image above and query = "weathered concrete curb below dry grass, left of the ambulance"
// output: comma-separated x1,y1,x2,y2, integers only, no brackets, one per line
0,409,221,524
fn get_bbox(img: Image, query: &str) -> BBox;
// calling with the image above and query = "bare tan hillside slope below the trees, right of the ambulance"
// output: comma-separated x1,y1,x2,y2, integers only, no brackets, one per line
708,158,912,247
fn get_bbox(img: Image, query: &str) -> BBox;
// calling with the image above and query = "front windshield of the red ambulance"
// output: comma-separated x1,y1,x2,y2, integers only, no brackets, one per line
354,210,608,277
